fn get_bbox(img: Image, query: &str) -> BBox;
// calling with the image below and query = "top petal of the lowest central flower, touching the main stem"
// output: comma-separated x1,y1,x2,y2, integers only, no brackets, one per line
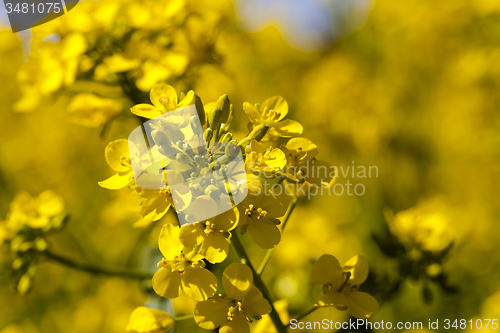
222,262,253,300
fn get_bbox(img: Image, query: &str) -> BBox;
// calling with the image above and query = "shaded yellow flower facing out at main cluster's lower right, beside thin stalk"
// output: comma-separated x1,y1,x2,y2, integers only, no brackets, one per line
238,183,291,249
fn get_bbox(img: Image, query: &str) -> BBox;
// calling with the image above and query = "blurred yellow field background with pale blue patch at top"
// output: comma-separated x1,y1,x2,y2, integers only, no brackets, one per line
0,0,500,333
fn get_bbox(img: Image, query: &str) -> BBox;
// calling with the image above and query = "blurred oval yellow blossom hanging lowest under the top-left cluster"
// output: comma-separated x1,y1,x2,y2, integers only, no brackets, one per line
68,93,123,127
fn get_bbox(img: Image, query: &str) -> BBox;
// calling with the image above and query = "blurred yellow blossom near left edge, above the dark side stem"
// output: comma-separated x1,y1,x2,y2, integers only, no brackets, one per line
6,190,64,233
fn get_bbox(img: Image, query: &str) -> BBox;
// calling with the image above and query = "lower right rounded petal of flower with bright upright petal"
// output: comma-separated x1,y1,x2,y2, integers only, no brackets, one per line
182,266,217,301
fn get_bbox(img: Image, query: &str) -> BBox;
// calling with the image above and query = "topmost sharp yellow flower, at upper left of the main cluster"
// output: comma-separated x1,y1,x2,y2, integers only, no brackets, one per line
130,83,195,119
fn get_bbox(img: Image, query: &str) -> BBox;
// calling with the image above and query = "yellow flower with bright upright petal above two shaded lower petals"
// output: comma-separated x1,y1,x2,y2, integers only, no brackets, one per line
153,224,217,301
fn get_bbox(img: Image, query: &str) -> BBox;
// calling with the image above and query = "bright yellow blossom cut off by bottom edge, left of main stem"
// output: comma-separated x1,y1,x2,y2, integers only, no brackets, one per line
127,306,175,333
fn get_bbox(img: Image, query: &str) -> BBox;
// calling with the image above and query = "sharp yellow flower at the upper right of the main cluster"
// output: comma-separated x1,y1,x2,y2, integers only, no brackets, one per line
243,96,303,142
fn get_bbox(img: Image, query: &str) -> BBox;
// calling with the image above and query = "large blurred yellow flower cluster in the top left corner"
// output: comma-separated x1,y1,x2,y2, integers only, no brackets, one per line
14,0,230,127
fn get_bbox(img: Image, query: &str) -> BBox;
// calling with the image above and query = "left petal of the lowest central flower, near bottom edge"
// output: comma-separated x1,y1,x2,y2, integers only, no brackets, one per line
194,297,231,330
